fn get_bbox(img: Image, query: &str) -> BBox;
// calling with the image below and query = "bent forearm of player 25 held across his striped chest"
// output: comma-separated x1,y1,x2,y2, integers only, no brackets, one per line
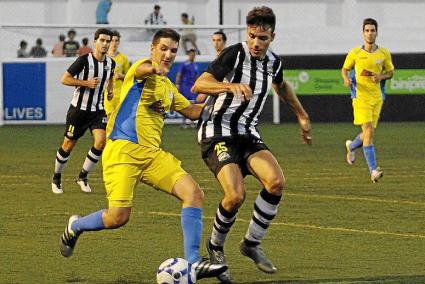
192,72,252,101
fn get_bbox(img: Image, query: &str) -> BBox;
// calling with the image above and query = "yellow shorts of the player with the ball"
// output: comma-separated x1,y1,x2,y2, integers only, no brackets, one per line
102,140,188,207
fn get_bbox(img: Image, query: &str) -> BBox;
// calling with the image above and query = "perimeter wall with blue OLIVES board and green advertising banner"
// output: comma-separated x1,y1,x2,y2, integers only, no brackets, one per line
1,54,425,124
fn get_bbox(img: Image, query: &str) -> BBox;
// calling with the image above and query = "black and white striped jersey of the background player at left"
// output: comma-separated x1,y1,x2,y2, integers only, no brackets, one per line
67,53,115,111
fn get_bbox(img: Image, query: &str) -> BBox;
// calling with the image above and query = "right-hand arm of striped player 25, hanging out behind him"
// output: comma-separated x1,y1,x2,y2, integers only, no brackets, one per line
273,81,312,145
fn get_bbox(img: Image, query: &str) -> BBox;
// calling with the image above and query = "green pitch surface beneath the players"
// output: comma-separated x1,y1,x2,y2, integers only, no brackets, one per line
0,123,425,283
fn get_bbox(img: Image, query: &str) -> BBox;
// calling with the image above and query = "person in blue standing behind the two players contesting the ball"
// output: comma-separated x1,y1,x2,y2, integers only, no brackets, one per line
176,48,199,128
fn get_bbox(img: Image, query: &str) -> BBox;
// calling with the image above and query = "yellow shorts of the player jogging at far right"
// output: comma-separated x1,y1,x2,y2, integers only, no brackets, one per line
353,98,383,128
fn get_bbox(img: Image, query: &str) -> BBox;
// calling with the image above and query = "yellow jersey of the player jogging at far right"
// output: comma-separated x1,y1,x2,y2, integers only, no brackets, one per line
343,46,394,100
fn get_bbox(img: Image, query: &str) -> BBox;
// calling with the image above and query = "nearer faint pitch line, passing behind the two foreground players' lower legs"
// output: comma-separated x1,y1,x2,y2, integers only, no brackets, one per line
147,211,425,239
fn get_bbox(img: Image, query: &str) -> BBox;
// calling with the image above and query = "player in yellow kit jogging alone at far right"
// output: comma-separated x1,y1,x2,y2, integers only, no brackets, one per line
341,18,394,183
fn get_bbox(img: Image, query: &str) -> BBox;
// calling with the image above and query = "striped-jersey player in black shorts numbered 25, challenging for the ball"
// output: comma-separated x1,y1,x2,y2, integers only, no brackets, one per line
193,6,311,283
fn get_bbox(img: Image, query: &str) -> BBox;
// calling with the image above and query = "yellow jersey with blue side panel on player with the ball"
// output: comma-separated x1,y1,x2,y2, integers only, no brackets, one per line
106,58,190,148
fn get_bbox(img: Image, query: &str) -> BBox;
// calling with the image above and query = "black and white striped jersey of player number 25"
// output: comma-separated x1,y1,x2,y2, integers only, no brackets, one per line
198,42,283,142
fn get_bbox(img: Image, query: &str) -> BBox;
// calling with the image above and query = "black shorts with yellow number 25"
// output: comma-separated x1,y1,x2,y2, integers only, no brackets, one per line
201,136,269,176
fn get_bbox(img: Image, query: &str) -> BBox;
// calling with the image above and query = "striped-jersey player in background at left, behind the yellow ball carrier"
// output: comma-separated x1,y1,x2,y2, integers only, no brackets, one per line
52,29,115,194
